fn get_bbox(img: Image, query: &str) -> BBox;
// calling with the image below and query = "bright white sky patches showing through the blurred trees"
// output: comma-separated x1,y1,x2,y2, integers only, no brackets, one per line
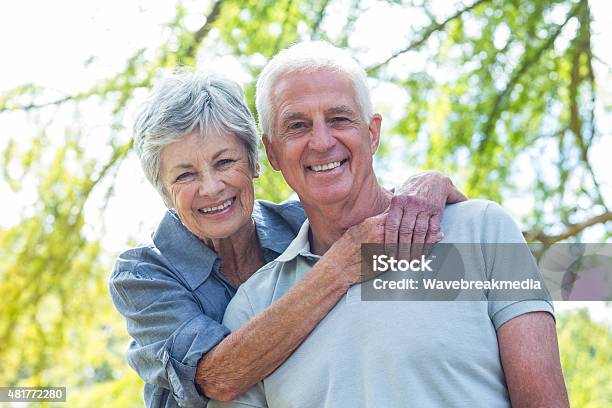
0,0,612,324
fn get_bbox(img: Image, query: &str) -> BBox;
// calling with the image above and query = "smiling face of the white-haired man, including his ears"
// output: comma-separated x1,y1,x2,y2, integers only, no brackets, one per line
264,71,381,205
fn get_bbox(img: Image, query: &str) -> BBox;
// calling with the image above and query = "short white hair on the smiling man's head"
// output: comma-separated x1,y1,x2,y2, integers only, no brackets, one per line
255,41,374,140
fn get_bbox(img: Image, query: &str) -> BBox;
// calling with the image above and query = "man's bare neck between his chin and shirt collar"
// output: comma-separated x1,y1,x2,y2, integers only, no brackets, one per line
302,175,392,255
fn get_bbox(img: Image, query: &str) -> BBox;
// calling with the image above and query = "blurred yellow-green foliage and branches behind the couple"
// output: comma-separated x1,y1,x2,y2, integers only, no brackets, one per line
0,0,612,407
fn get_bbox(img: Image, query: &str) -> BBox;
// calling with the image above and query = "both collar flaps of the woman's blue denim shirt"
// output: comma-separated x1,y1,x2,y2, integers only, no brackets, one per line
152,201,298,290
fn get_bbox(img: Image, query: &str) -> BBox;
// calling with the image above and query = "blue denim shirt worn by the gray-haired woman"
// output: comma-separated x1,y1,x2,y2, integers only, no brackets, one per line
109,200,306,407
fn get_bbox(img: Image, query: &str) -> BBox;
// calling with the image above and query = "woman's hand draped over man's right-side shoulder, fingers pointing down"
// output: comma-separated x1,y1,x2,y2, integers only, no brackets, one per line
384,170,467,259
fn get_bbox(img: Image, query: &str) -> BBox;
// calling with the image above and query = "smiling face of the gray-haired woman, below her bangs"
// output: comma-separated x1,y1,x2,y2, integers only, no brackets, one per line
161,129,255,240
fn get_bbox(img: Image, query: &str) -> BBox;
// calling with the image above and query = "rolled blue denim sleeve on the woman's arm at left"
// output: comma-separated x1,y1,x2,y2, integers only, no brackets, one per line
109,263,229,407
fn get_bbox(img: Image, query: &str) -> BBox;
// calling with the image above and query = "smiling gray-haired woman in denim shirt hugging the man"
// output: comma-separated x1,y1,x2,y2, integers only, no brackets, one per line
110,74,464,407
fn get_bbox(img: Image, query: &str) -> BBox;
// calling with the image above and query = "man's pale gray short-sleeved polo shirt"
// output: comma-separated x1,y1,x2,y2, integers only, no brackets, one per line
208,200,553,408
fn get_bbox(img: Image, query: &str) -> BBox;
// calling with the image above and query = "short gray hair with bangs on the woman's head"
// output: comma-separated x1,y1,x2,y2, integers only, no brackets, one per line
134,72,259,207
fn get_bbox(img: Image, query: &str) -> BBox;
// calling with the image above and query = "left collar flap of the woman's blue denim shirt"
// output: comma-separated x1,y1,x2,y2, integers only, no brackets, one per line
152,210,221,290
